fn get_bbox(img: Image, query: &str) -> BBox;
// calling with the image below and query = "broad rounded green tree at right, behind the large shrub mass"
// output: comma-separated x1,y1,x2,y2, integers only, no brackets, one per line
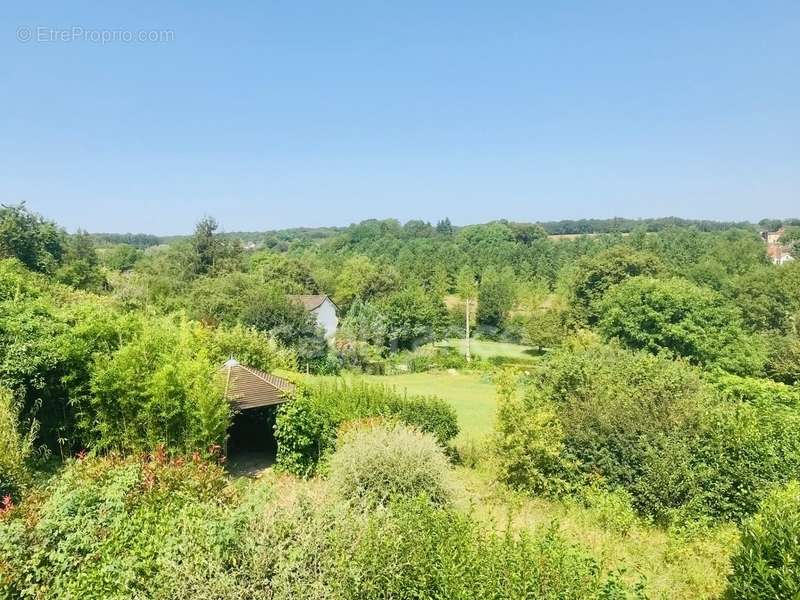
598,277,765,375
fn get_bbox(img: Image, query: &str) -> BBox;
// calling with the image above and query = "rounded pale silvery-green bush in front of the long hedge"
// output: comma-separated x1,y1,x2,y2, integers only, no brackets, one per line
329,422,453,507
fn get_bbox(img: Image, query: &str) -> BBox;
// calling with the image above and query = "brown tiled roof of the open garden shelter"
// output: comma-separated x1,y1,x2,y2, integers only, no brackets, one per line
220,358,295,410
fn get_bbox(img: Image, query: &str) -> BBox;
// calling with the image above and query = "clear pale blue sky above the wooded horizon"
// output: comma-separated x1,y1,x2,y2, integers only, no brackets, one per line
0,0,800,234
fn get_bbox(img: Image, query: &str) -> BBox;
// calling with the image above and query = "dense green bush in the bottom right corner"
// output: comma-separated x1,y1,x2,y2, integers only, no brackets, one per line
725,481,800,600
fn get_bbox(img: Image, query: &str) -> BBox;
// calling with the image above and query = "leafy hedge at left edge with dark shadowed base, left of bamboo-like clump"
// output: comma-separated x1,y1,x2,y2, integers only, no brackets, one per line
0,270,130,451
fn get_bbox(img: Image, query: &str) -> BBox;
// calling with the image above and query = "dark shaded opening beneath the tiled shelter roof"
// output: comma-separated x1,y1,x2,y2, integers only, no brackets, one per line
227,406,278,475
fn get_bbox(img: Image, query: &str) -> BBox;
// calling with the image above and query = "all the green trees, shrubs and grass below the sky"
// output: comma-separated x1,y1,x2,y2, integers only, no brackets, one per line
0,205,800,598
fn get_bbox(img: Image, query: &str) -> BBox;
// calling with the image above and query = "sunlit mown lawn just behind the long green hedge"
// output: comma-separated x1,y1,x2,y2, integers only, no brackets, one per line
364,371,496,439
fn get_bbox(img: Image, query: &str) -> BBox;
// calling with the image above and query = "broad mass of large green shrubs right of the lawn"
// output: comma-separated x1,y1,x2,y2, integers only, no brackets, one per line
494,344,800,522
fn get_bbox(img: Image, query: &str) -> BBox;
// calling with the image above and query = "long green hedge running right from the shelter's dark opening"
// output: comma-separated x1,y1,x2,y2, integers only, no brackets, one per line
275,380,458,476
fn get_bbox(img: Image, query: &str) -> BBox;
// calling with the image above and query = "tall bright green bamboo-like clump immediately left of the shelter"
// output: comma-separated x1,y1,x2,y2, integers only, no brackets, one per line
88,318,230,451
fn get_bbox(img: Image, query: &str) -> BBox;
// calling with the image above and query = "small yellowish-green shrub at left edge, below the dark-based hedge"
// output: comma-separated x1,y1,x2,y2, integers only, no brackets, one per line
0,388,36,502
